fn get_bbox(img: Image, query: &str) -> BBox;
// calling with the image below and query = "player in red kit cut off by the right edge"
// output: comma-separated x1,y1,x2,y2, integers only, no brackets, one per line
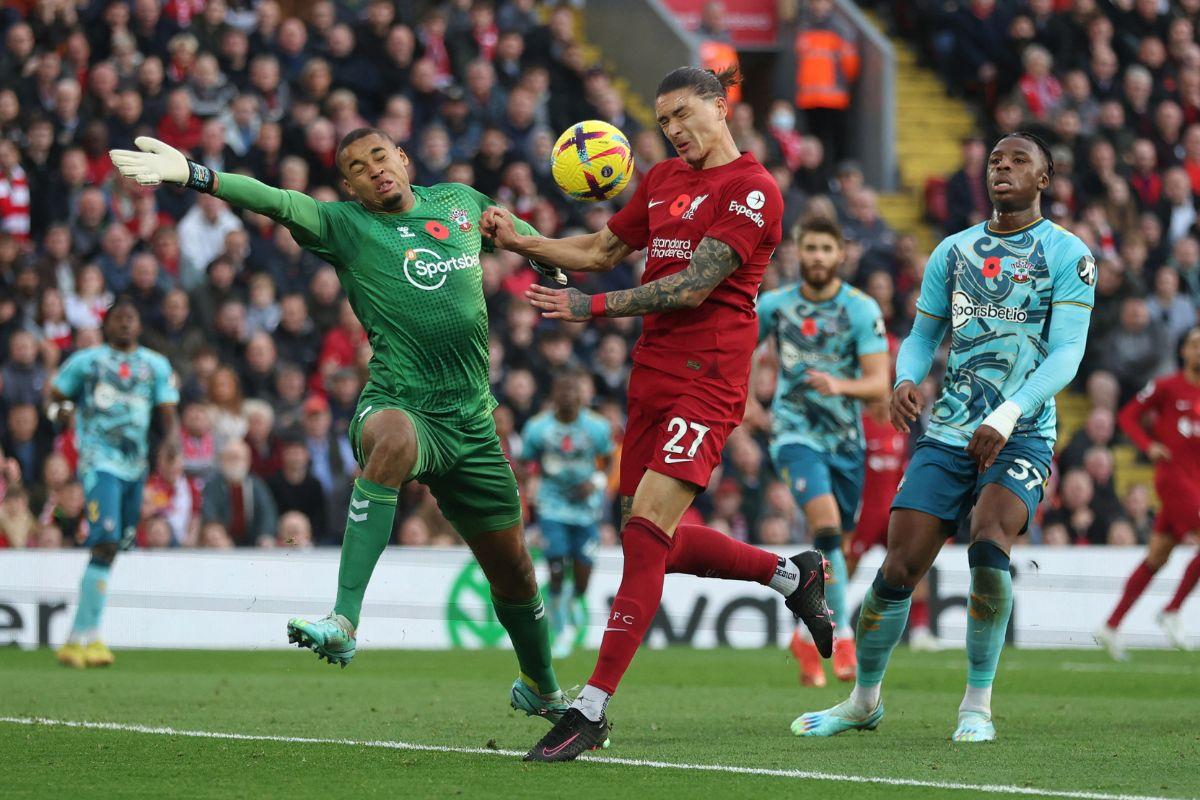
1096,327,1200,661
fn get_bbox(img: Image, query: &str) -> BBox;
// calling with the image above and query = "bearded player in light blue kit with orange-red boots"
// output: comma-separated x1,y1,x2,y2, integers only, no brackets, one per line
758,218,889,686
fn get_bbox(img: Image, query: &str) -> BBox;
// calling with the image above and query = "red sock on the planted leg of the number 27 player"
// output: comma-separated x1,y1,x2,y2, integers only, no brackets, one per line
588,517,671,694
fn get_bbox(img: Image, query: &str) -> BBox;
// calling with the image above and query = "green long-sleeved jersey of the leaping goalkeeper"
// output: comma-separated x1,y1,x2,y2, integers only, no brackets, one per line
216,173,536,421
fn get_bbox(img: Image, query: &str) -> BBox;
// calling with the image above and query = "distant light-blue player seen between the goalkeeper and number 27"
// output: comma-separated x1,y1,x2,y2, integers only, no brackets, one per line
521,372,614,658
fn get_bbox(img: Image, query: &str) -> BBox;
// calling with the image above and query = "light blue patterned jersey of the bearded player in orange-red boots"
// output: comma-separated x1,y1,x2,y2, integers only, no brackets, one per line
758,283,888,453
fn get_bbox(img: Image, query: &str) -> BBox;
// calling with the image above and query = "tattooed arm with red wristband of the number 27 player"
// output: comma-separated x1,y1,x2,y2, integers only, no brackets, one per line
526,237,742,323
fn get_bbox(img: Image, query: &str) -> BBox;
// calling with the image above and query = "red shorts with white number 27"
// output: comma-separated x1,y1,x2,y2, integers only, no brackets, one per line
620,363,746,497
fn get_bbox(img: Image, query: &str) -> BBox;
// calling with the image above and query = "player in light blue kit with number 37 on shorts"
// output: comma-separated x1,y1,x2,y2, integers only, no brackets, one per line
792,132,1096,741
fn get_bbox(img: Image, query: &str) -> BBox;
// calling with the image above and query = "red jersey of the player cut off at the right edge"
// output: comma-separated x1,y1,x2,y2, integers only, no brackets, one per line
1117,372,1200,485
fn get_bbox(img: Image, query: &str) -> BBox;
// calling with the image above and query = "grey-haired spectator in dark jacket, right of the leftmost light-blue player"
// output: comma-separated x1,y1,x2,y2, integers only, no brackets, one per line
200,439,278,547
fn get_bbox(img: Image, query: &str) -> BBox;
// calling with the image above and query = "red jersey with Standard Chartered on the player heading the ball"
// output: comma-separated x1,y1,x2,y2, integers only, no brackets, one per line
608,154,784,386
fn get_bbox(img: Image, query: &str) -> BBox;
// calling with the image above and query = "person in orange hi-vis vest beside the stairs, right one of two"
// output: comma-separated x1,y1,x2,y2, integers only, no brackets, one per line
796,0,859,162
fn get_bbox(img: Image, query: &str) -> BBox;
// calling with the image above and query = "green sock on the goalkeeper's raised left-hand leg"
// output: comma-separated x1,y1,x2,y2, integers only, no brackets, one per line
334,477,400,630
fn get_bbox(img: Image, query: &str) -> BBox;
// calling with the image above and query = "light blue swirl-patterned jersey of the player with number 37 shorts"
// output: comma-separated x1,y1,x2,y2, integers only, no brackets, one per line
917,219,1096,447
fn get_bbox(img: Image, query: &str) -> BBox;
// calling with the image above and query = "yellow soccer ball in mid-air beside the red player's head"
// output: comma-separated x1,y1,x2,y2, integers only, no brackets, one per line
551,120,634,203
